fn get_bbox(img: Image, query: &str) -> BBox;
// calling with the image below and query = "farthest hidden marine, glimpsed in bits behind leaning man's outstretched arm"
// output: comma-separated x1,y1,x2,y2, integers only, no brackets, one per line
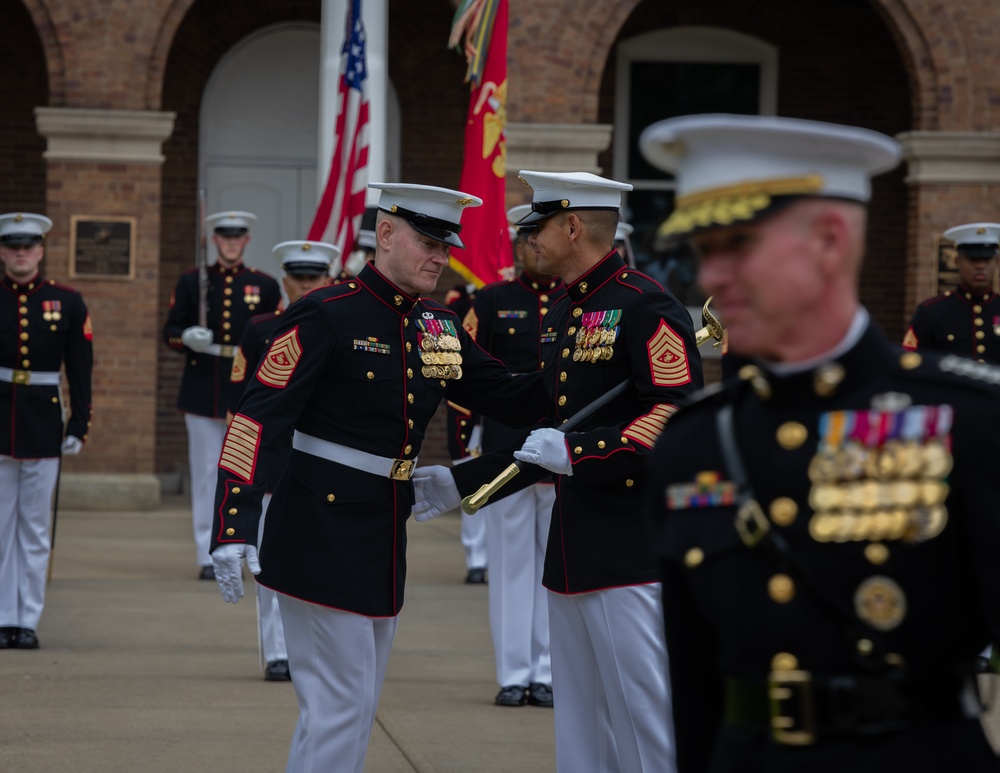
444,282,487,585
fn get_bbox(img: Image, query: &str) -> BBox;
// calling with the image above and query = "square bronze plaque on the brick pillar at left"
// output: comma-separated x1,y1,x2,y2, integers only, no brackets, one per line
69,215,136,279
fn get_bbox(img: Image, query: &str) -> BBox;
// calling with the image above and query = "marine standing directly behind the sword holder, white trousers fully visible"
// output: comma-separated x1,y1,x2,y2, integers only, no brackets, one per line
462,204,566,707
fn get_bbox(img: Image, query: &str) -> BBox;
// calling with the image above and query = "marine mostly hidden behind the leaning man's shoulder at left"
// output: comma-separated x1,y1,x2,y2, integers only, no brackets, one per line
229,241,340,682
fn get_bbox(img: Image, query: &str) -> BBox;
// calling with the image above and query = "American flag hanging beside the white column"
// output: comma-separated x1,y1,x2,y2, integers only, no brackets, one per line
308,0,368,255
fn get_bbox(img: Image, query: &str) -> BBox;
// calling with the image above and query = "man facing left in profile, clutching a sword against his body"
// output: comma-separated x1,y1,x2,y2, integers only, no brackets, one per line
418,171,702,773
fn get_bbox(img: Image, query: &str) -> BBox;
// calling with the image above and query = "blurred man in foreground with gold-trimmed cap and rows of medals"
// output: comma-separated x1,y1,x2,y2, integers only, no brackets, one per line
641,115,1000,773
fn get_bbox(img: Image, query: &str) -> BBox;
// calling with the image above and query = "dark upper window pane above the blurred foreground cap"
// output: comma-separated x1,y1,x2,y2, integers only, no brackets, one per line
628,61,760,180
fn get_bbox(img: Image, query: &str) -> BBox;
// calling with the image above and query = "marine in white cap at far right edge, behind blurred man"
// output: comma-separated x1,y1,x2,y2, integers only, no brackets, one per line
903,223,1000,365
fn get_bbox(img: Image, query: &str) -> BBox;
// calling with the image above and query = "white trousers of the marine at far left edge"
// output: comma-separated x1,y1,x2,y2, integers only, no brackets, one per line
0,456,59,631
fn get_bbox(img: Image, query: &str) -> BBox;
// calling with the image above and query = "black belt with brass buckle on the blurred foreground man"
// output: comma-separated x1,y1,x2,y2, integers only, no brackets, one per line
725,670,982,746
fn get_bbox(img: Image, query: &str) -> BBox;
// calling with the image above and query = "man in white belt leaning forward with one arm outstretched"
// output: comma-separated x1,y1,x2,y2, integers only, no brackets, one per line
212,183,544,773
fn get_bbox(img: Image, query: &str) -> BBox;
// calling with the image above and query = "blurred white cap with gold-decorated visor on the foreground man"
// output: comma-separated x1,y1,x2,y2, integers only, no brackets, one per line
639,114,902,236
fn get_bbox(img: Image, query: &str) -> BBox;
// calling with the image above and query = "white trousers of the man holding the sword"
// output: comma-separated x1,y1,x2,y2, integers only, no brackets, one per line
549,583,676,773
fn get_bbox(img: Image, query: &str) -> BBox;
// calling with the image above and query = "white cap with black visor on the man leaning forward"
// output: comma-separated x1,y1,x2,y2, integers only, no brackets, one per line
368,183,483,250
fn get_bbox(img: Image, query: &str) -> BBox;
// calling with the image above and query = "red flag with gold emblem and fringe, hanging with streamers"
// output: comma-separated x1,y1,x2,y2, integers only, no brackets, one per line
449,0,514,287
